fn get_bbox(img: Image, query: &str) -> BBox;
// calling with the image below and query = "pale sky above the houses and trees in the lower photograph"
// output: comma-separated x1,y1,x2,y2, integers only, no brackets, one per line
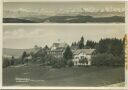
3,24,125,49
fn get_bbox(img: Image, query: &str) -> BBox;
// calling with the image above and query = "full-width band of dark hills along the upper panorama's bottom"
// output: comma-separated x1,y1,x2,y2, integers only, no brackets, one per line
3,15,125,23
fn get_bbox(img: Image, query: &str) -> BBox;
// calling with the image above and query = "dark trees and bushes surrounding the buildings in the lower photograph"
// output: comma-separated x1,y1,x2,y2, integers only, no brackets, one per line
3,36,125,68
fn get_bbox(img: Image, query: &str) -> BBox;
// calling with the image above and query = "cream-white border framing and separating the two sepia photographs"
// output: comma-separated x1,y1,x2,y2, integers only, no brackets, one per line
0,0,128,90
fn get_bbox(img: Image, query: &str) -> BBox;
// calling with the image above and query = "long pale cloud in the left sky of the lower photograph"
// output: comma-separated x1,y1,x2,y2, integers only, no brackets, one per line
4,28,60,40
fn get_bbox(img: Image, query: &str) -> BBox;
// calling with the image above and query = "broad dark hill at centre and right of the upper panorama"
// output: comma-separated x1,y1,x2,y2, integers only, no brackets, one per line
44,15,125,23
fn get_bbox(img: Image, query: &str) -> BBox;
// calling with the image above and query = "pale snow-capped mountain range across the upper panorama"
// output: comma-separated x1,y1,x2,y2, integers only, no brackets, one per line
3,8,125,18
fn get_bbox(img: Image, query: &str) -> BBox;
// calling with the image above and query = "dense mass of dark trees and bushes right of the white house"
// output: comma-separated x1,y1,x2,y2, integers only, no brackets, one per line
92,38,125,66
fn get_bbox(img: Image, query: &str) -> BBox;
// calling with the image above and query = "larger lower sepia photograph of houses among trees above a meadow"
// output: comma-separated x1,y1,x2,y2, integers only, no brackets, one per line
2,24,125,87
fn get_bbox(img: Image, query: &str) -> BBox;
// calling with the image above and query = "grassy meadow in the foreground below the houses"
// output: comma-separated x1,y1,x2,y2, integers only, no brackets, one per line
3,65,124,87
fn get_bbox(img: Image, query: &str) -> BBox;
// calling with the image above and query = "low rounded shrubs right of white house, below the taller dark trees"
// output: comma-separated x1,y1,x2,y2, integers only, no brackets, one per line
92,53,124,66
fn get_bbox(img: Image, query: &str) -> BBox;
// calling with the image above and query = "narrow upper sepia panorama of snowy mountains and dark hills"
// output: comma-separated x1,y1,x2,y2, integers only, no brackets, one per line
3,0,125,23
